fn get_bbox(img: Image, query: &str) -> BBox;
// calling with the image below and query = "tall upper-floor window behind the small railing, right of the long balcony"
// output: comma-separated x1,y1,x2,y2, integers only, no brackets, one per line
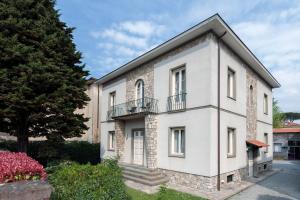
172,67,186,101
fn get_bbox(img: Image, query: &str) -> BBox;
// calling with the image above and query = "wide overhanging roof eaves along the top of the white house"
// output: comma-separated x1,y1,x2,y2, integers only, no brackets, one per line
96,14,280,88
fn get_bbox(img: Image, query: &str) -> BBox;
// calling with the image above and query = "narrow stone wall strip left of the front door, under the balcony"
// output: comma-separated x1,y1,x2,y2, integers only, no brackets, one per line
115,120,125,162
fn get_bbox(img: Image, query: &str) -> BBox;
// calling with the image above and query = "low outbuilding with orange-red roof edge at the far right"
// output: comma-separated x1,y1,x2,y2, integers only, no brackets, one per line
273,127,300,160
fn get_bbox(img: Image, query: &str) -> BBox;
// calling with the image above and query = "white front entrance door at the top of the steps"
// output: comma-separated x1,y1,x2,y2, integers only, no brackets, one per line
133,130,144,165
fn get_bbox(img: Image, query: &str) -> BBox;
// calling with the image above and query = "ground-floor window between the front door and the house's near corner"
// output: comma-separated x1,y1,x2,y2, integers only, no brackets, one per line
169,127,185,157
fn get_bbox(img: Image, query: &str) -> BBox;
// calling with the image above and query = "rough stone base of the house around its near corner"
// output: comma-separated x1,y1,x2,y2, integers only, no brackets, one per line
160,168,247,192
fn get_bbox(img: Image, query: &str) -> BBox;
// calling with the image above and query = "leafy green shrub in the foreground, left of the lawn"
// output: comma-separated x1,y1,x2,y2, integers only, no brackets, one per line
49,160,129,200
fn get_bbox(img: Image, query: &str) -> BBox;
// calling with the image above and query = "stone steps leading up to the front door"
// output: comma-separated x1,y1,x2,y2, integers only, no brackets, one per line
119,163,168,186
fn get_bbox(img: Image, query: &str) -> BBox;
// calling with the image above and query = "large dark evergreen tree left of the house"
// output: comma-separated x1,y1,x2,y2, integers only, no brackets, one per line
0,0,88,152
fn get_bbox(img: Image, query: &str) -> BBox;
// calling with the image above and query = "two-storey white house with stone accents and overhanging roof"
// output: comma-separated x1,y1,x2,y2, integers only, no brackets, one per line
94,15,280,191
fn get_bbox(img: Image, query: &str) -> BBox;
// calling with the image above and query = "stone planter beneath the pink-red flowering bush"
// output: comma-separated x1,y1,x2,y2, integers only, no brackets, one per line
0,181,52,200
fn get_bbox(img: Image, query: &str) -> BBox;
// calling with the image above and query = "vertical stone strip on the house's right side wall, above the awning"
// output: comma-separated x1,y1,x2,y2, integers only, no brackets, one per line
246,69,257,139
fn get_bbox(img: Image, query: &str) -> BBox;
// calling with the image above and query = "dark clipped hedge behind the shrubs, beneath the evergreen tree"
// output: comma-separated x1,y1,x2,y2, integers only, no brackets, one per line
0,140,100,166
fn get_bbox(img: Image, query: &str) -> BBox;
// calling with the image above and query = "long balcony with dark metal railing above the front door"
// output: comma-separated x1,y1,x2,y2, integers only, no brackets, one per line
107,97,158,120
